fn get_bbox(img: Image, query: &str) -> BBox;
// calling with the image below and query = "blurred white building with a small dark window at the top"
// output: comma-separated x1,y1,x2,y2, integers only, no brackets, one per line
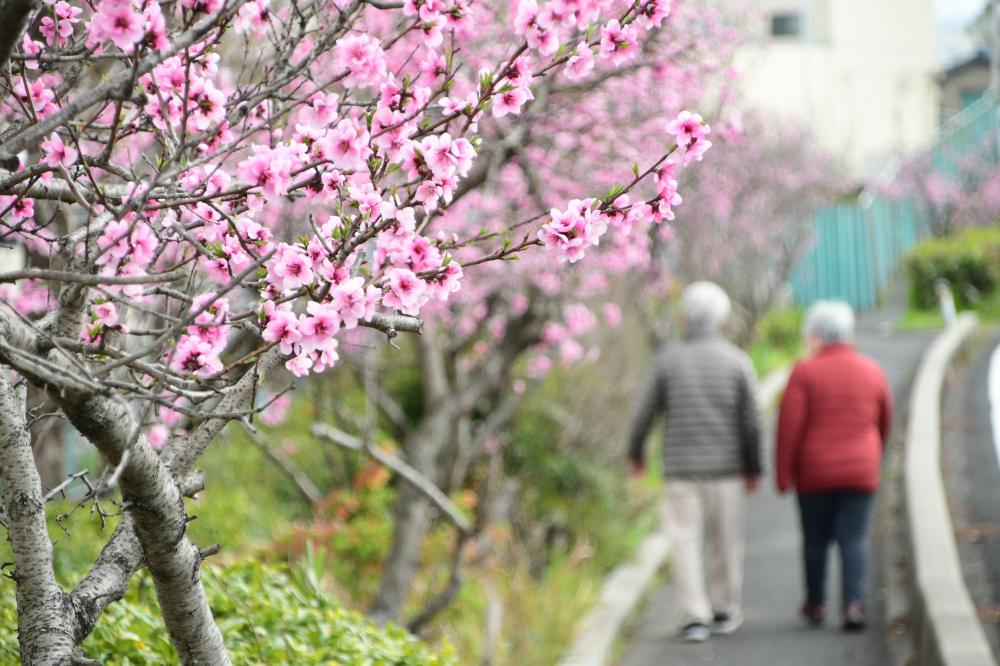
740,0,939,179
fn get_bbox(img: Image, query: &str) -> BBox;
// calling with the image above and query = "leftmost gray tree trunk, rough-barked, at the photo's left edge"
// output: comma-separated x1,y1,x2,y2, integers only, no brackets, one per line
0,375,76,666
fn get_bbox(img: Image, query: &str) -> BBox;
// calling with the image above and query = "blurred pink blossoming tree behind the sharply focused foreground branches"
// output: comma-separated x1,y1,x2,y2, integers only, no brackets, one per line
300,4,736,627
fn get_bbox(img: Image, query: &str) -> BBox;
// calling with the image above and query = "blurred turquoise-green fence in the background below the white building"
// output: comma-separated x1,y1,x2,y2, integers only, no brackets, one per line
791,93,1000,310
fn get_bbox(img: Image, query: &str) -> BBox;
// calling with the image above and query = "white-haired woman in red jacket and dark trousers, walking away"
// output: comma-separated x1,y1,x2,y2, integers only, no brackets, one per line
776,301,892,631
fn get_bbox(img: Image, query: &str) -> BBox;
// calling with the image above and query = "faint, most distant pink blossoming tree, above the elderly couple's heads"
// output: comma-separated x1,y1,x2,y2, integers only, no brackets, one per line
667,110,846,340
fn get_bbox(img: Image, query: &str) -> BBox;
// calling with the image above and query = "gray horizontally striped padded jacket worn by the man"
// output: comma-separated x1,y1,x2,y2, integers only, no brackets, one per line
629,335,763,477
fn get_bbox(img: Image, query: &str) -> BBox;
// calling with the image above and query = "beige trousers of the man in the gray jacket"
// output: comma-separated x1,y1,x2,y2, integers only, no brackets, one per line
663,478,746,624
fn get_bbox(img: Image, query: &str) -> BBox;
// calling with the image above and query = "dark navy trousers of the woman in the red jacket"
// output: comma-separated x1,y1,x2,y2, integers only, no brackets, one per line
799,492,875,605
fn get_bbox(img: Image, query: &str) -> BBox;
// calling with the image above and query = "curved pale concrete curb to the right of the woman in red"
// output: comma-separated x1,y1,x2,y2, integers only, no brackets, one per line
903,313,997,666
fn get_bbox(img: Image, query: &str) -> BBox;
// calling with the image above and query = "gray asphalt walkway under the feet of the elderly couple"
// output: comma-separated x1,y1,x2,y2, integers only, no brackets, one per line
620,303,933,666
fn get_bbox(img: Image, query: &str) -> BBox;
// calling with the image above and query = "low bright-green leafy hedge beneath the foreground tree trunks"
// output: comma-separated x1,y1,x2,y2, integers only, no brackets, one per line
0,561,457,666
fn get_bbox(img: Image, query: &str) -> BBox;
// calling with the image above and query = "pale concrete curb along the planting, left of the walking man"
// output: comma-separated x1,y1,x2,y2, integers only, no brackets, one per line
560,368,790,666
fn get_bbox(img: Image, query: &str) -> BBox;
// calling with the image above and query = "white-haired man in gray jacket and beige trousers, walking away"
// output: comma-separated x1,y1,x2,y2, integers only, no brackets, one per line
629,282,761,642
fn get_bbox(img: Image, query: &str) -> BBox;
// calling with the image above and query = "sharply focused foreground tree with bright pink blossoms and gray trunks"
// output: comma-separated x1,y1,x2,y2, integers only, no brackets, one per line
0,0,707,664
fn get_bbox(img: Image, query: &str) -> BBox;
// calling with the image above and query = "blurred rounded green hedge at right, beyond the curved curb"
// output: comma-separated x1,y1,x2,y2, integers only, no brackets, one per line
907,227,1000,310
